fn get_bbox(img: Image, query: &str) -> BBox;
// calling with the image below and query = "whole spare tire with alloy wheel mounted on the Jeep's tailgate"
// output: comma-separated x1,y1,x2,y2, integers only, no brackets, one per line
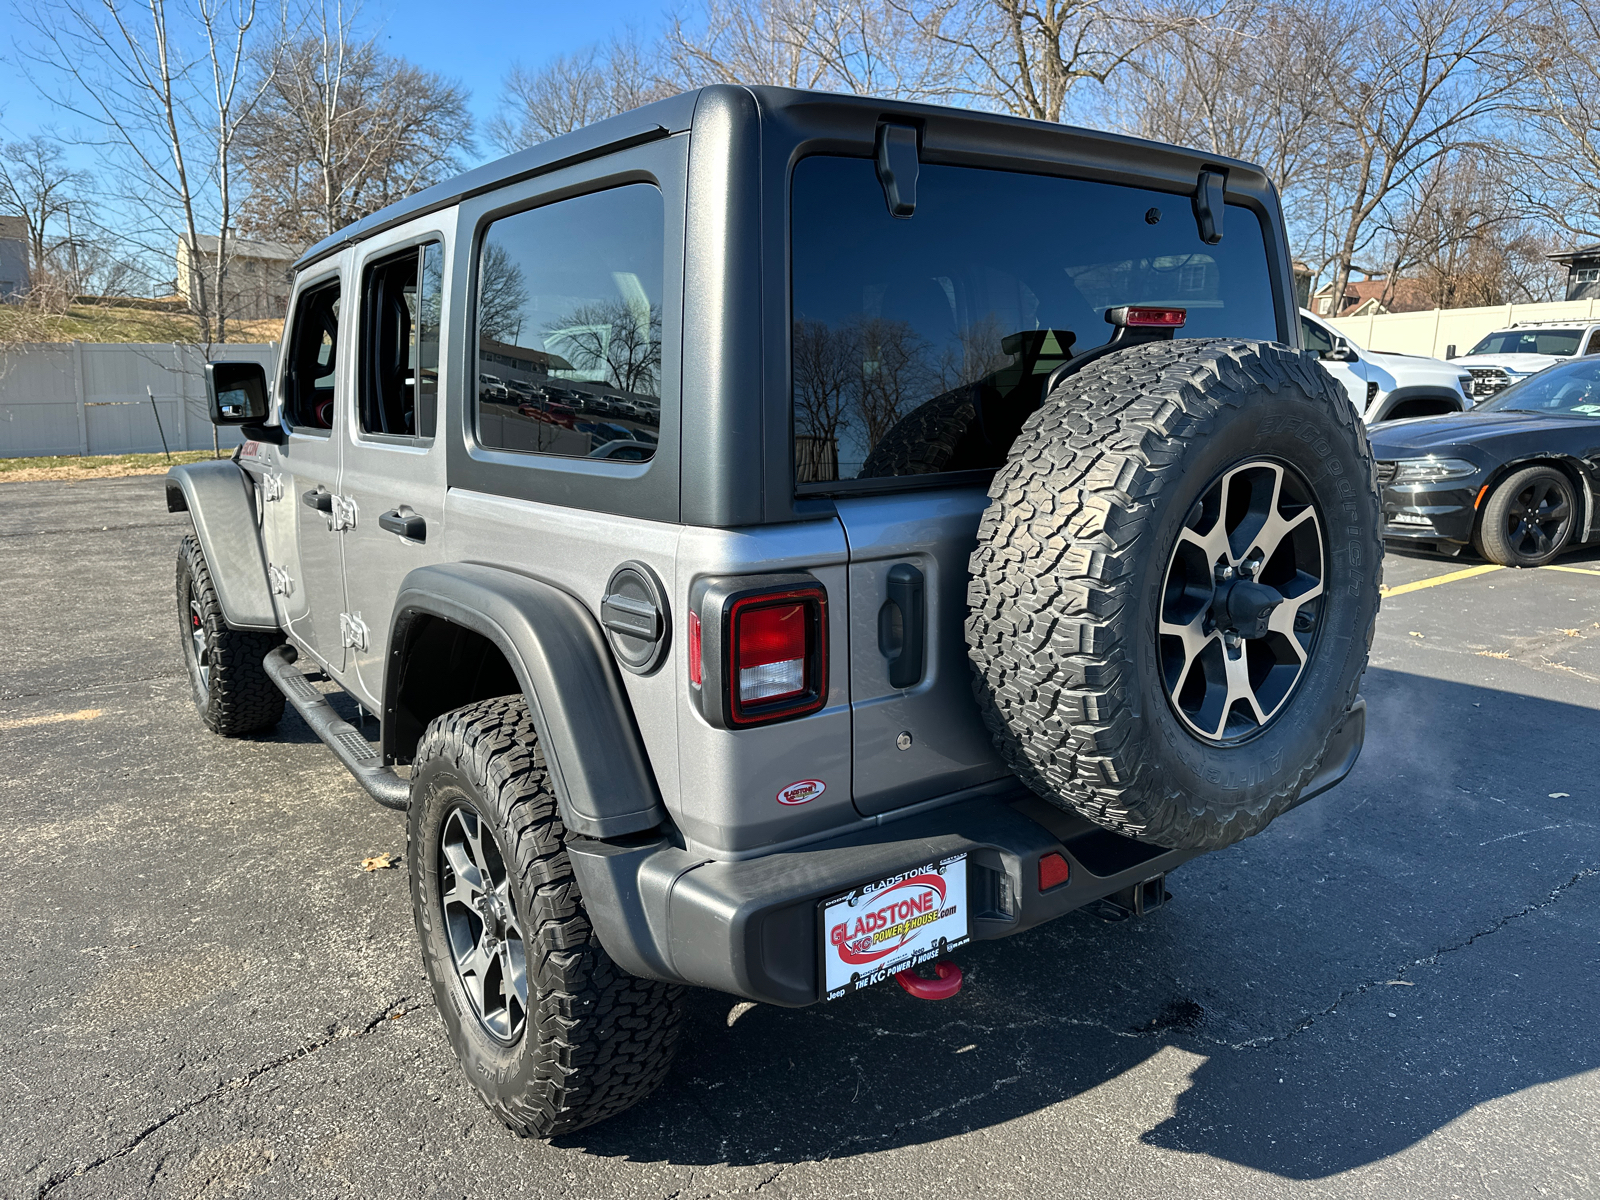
966,339,1382,850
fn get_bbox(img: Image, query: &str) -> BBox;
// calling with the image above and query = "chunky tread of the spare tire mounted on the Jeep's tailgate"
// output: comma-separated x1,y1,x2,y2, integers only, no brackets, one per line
966,339,1382,850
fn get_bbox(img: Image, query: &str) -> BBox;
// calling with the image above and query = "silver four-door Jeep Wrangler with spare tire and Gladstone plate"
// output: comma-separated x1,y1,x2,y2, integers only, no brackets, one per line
166,86,1382,1136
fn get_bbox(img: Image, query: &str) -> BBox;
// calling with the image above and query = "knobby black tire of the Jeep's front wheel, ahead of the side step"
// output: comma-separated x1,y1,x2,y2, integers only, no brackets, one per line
178,533,283,738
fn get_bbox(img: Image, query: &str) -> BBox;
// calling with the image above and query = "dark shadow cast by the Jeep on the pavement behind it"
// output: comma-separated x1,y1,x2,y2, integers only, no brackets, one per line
555,669,1600,1179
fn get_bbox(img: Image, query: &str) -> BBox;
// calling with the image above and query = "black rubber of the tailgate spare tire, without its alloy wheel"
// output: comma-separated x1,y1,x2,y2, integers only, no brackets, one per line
966,339,1382,850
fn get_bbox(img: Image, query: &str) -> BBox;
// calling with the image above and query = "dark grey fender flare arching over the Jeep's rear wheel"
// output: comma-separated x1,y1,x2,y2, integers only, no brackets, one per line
384,563,667,840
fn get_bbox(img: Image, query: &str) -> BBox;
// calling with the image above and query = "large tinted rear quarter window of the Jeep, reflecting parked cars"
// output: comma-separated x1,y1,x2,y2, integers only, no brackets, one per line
477,184,666,462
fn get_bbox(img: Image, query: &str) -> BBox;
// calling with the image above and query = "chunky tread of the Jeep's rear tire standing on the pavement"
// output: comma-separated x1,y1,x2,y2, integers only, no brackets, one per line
408,696,683,1138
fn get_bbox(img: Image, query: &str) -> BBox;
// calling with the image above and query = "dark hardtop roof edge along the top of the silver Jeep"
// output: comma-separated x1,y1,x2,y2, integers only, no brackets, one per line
294,83,1267,270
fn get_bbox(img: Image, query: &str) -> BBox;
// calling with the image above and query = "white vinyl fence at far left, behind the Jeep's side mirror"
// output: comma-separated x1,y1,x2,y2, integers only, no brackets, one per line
0,342,278,458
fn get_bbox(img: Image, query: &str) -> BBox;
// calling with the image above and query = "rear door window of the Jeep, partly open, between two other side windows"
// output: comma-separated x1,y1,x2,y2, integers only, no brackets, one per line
360,242,443,437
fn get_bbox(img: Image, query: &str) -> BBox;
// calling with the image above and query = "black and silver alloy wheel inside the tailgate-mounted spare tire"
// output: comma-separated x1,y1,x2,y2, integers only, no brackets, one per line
1157,459,1328,746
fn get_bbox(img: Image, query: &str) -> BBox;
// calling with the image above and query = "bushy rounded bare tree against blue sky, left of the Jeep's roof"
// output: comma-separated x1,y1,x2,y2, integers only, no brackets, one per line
240,0,472,246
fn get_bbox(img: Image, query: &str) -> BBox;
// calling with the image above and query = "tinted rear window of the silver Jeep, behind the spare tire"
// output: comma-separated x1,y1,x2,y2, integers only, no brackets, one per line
790,157,1278,491
